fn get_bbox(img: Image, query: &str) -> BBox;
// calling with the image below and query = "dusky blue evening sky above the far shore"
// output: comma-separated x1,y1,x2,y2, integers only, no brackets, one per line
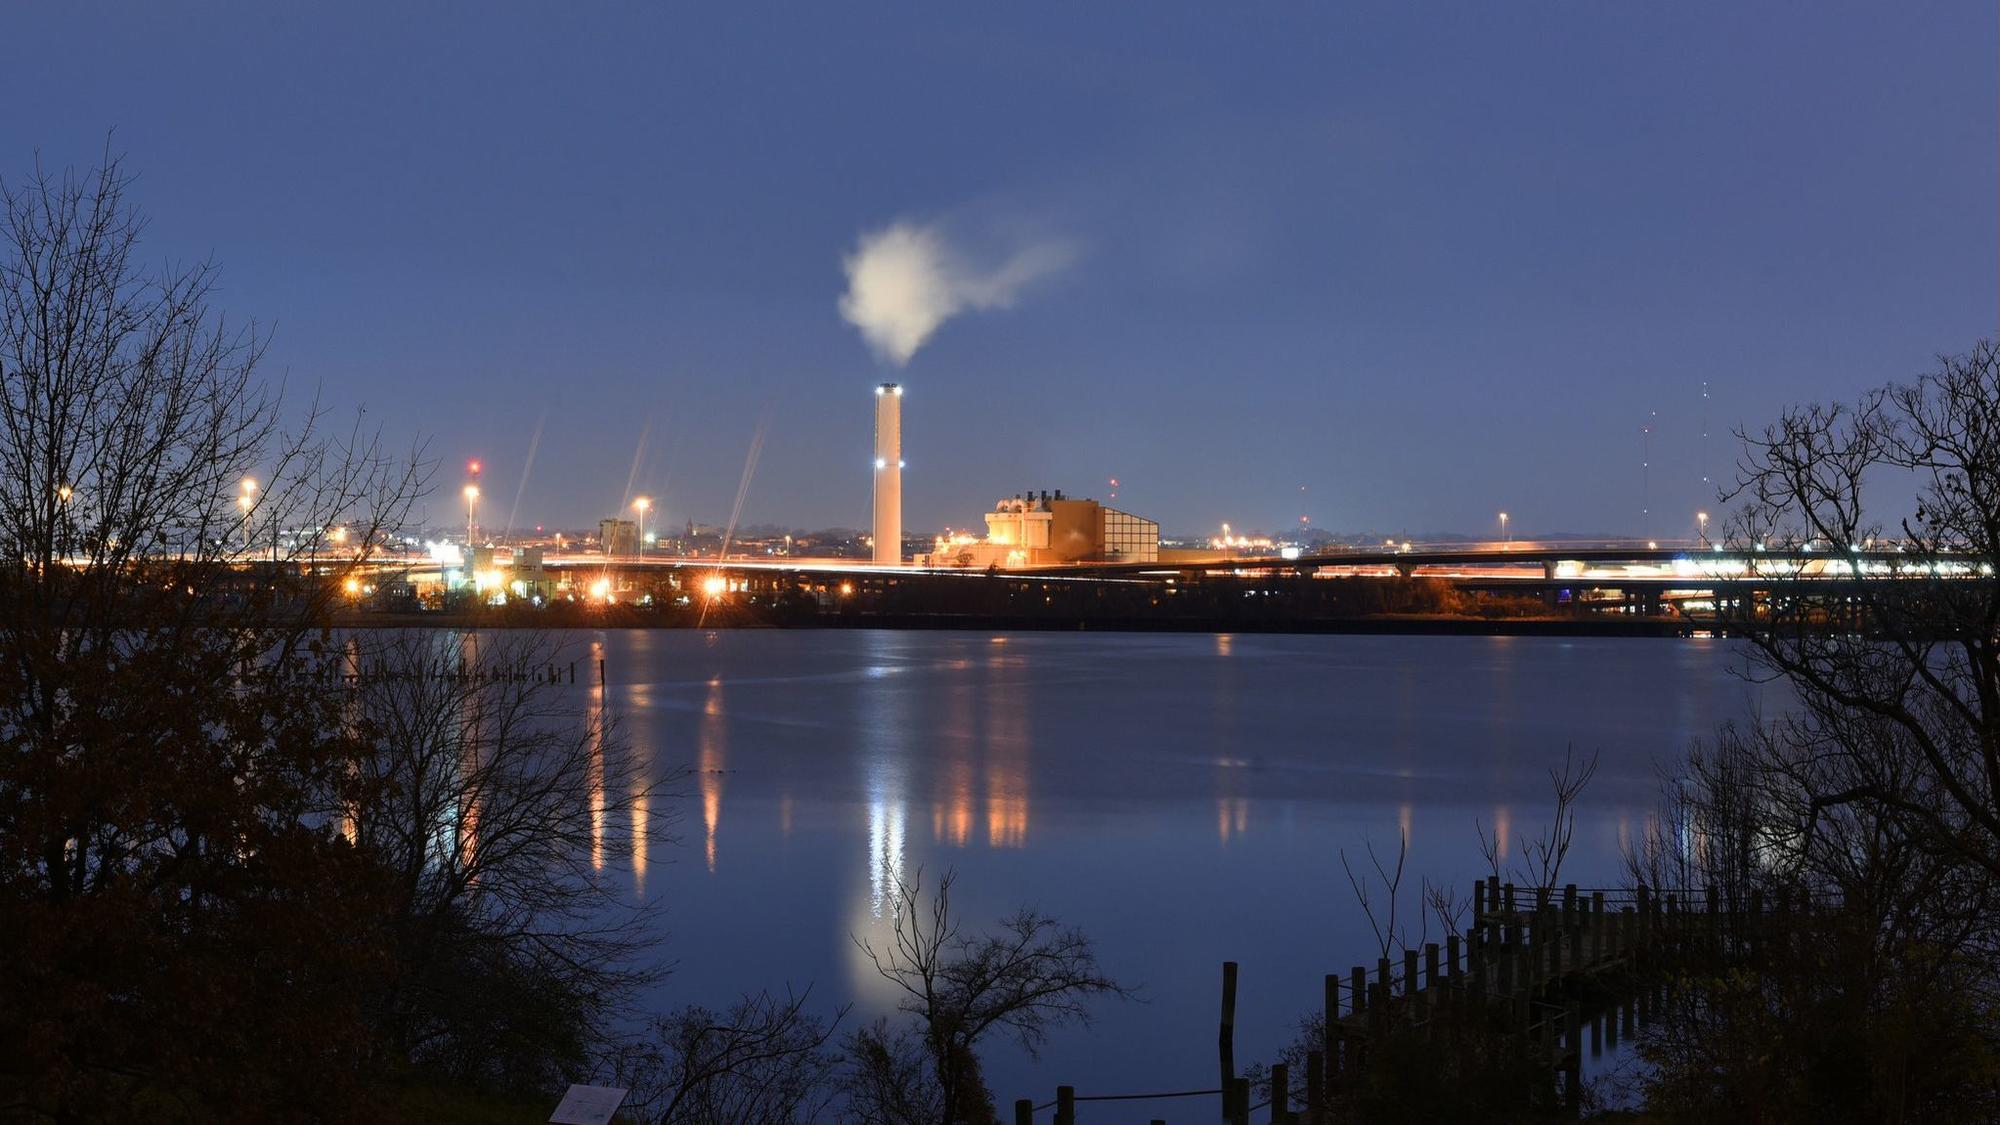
0,2,2000,536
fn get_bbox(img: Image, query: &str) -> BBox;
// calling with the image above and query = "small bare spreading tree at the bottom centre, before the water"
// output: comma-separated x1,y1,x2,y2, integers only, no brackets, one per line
850,871,1134,1125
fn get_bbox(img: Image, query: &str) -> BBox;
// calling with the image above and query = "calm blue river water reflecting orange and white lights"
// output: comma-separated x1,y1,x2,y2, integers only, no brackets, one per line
580,631,1772,1121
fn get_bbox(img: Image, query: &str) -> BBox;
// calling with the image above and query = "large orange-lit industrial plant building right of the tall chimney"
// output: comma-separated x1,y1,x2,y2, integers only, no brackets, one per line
926,488,1160,571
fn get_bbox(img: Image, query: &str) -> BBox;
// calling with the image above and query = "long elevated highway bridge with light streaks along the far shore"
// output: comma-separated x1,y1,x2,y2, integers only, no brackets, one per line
324,540,1992,621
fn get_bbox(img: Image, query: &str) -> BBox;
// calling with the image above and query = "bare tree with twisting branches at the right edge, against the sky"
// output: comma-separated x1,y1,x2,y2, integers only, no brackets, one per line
1730,340,2000,879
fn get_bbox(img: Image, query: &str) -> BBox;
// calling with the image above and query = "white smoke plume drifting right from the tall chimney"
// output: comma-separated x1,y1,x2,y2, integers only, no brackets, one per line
840,220,1076,366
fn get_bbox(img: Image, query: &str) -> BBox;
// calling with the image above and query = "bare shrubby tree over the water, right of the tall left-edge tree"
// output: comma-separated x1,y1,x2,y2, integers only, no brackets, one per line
334,631,680,1089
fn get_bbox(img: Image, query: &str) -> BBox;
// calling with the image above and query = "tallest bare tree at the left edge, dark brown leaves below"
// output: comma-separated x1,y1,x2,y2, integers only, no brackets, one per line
0,149,426,1117
